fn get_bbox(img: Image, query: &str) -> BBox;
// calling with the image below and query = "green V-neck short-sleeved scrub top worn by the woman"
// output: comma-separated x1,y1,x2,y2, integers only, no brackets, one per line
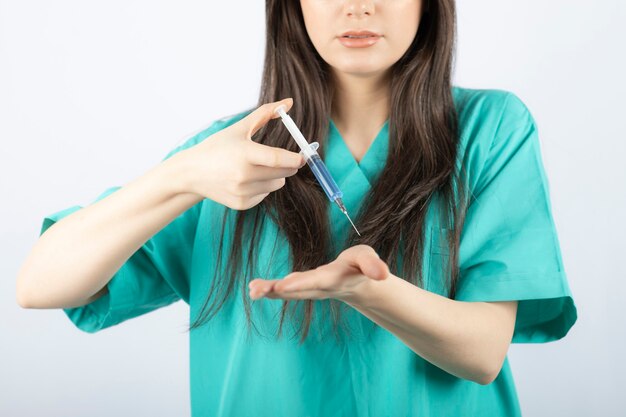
41,87,577,417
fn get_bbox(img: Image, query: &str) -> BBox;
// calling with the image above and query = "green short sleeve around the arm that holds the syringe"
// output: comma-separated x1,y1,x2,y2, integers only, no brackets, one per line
40,121,234,333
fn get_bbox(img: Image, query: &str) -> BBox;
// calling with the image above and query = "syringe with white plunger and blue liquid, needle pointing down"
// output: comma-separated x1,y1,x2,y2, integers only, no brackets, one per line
275,105,361,236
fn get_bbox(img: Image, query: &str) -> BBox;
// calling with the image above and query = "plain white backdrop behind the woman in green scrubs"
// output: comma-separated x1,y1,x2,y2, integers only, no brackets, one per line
0,0,626,417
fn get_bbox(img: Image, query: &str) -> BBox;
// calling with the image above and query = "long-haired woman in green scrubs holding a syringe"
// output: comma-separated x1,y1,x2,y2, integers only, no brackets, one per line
18,0,576,416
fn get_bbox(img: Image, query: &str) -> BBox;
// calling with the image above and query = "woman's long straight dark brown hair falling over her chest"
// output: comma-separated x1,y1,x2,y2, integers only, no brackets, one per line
190,0,465,343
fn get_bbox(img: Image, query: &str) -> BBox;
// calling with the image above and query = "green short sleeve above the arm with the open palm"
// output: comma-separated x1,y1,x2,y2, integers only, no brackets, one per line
456,93,577,343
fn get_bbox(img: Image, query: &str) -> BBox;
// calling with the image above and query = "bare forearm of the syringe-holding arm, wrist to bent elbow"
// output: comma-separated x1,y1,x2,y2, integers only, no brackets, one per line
17,155,201,308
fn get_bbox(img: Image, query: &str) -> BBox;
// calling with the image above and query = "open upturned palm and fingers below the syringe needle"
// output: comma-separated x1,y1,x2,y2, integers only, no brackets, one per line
248,245,389,301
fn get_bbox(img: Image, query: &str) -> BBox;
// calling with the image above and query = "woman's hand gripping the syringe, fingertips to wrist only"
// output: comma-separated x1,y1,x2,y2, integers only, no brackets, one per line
172,98,306,210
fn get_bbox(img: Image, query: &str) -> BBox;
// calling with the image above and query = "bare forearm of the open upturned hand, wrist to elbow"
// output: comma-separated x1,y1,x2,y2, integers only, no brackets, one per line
344,274,516,384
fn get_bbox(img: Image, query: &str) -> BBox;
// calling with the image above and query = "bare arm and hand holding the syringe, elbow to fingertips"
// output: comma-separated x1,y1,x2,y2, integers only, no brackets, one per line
16,99,304,308
